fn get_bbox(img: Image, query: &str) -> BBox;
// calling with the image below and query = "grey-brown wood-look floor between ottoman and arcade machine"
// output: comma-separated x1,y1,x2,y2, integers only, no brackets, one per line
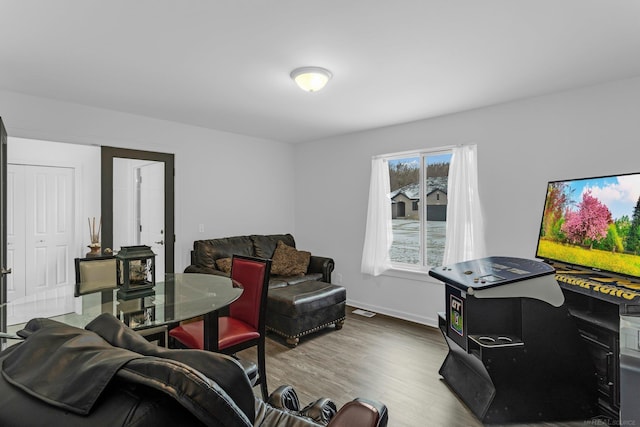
238,307,604,427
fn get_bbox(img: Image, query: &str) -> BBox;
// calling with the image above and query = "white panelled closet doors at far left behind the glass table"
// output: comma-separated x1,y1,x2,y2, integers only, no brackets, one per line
7,165,75,324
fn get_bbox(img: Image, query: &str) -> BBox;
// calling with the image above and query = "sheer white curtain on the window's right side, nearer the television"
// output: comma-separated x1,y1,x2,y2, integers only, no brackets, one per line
442,145,486,265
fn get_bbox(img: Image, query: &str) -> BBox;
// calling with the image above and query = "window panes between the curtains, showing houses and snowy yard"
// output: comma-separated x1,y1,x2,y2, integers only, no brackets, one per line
387,150,452,268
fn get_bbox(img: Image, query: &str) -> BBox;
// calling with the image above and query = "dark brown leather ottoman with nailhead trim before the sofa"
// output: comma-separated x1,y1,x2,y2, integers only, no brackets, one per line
266,280,347,347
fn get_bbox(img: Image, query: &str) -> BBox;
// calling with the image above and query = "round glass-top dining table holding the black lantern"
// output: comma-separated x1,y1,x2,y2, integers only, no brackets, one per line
4,273,242,350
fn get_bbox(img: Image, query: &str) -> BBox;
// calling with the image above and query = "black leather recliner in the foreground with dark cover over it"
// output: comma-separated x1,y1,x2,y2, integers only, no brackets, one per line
0,314,387,427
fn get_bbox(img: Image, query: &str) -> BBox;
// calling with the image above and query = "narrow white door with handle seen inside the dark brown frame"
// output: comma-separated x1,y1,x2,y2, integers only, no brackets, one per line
137,162,166,280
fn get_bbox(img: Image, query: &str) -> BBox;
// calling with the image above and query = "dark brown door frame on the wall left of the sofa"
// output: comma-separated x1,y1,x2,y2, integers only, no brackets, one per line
100,146,176,273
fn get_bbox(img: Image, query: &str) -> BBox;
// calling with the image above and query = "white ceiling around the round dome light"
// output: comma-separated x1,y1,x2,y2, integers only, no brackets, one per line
0,0,640,142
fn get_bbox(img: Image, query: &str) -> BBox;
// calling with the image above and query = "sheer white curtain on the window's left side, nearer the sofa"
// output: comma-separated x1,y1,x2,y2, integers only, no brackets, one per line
361,158,393,276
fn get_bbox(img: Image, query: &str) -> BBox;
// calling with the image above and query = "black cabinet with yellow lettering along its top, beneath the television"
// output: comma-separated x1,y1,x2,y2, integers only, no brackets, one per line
554,264,640,422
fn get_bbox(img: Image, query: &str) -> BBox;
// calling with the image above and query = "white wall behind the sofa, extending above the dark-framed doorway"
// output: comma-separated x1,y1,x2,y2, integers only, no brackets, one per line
0,91,295,271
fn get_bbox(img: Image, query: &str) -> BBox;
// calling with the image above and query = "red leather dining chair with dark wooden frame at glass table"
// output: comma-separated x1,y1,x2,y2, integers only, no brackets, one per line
169,255,271,400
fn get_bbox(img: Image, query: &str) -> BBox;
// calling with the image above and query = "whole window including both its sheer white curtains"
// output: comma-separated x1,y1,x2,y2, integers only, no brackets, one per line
361,145,486,276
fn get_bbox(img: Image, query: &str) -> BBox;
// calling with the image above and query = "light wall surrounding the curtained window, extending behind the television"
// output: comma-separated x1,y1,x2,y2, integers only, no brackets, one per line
295,78,640,325
